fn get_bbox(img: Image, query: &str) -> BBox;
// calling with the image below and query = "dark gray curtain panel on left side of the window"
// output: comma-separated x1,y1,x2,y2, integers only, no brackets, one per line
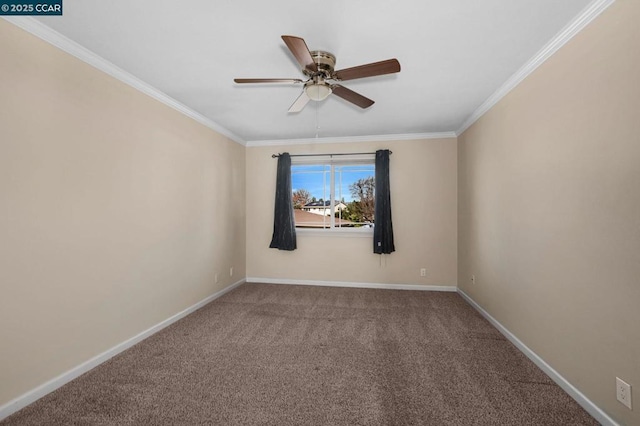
269,152,296,251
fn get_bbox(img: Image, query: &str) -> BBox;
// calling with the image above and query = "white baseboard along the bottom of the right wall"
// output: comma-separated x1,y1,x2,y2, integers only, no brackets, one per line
458,288,619,426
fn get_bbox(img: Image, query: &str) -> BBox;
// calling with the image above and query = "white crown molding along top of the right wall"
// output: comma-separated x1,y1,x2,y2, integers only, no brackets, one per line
455,0,615,135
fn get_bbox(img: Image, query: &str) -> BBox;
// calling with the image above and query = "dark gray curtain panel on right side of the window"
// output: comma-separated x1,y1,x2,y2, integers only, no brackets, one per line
373,149,396,254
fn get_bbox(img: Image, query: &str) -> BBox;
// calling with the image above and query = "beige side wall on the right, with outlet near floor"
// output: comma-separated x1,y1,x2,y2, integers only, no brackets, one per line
458,0,640,425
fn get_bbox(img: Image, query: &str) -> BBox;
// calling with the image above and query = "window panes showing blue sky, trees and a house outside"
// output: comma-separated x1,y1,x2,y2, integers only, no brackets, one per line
291,162,375,229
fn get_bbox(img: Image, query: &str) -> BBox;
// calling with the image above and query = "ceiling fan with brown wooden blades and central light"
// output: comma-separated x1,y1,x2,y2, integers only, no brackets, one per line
233,35,400,112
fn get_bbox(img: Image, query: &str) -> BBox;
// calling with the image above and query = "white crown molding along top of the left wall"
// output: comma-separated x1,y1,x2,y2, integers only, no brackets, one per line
2,16,245,145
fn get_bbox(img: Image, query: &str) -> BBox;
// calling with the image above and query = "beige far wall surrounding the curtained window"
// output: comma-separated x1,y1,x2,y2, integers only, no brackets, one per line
247,139,457,286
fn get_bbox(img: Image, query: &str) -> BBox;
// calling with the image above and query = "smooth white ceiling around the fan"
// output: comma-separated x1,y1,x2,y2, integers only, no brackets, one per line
26,0,602,143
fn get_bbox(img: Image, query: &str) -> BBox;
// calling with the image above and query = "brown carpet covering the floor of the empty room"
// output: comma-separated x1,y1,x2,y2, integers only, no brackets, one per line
0,284,598,426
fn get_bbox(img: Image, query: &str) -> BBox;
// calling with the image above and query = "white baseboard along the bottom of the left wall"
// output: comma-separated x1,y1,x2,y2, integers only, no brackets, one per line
0,279,245,420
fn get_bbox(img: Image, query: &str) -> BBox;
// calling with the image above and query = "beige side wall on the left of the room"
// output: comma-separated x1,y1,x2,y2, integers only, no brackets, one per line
0,20,245,406
